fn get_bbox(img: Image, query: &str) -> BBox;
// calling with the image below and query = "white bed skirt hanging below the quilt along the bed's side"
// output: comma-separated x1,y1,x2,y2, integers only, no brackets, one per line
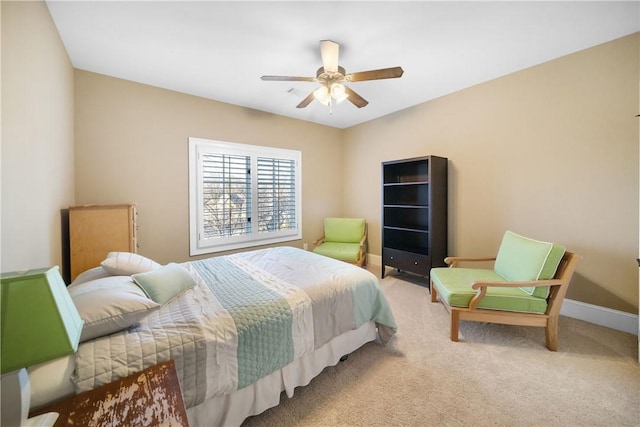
187,322,377,427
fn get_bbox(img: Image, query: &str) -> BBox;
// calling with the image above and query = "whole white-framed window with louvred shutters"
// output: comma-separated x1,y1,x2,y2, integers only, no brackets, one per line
189,138,302,255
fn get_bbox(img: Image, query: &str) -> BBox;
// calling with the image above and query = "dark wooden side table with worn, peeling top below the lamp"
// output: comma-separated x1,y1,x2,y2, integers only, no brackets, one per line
29,360,189,427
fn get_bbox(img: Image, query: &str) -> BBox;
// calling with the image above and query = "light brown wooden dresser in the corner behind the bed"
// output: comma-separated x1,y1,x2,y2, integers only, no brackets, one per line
69,204,137,280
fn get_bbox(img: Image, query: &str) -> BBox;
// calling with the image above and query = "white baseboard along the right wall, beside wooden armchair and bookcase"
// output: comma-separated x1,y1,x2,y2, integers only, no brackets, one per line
367,254,639,335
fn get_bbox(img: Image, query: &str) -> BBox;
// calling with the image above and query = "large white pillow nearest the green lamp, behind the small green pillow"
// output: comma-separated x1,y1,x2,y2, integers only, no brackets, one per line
69,276,160,342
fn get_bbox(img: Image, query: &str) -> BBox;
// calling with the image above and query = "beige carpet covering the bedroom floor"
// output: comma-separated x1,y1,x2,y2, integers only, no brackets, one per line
243,275,640,427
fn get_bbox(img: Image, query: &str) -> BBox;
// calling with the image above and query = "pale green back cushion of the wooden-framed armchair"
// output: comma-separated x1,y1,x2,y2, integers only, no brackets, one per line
494,231,565,298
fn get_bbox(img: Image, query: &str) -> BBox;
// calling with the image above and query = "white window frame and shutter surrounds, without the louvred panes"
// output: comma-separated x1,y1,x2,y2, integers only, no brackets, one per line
189,138,302,256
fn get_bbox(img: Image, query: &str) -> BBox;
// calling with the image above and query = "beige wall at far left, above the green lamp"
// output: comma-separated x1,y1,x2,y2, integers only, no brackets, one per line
0,1,74,272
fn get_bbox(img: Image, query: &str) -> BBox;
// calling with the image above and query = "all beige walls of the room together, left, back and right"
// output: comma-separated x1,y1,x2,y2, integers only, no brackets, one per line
1,2,640,313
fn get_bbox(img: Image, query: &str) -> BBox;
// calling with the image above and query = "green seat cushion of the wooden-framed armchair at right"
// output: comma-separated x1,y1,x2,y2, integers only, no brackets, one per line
430,267,547,314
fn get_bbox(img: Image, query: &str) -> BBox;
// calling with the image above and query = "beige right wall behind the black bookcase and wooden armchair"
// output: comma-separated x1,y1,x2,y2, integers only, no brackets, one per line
343,34,640,313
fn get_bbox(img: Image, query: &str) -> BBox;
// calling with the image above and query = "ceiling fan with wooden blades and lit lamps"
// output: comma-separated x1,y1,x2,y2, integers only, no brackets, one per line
260,40,404,108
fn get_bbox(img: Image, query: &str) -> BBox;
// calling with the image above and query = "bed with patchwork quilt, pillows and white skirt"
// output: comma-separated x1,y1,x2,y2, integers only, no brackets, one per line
29,247,397,426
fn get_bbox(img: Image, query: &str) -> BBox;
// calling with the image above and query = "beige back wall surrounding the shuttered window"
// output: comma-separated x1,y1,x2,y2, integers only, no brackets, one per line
75,70,342,263
